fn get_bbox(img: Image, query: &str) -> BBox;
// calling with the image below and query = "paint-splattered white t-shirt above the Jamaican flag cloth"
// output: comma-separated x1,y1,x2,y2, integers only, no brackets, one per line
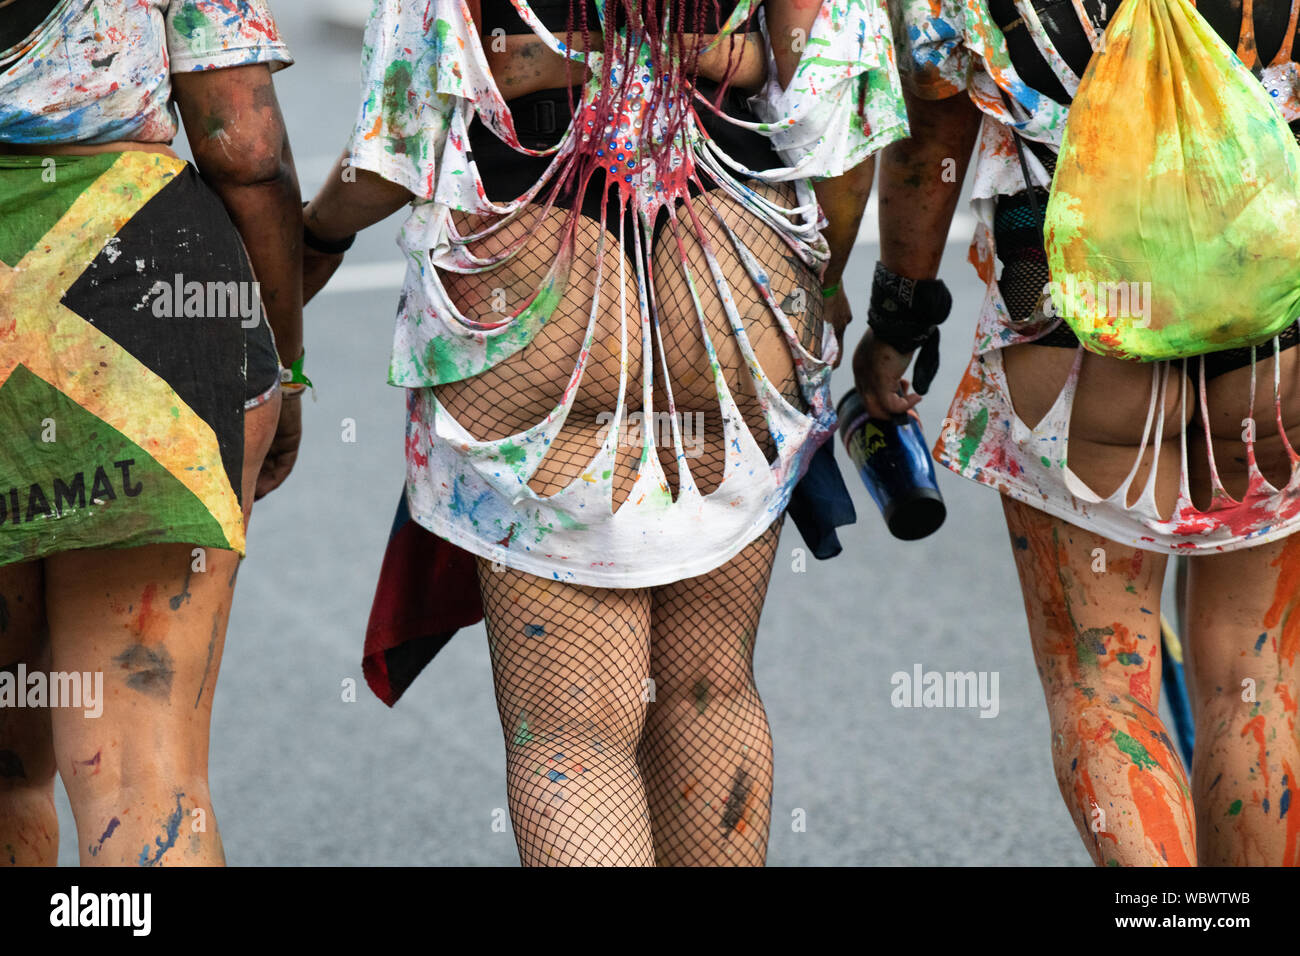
0,0,293,144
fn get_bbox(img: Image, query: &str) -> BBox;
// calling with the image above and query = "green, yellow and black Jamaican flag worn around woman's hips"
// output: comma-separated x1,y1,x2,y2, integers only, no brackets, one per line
0,152,278,566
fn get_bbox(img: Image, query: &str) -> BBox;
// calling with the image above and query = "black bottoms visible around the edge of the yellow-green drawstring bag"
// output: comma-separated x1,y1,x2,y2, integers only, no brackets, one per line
993,187,1300,381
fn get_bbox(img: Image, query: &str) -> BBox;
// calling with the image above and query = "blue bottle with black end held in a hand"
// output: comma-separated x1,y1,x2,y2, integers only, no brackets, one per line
836,390,948,541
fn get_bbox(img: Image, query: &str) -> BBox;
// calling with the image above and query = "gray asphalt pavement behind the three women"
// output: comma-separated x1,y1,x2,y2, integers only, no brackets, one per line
50,0,1107,865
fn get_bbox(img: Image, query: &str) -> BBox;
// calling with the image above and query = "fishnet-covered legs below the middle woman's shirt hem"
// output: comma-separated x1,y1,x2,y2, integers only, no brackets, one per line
478,522,780,866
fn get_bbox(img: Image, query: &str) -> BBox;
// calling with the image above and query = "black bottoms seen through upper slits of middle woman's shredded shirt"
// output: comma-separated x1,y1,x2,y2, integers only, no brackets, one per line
469,79,785,261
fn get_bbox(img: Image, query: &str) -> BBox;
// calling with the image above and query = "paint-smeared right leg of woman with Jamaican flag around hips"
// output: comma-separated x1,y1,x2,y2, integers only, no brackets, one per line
44,398,280,866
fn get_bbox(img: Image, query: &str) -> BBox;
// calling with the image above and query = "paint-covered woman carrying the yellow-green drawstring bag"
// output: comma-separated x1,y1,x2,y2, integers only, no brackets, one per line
853,0,1300,865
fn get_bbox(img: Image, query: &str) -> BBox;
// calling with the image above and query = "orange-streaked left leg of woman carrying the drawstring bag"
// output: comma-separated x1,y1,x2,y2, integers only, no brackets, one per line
1002,497,1196,866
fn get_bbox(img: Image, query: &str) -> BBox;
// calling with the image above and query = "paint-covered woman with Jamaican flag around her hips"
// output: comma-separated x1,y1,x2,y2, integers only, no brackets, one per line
0,0,303,866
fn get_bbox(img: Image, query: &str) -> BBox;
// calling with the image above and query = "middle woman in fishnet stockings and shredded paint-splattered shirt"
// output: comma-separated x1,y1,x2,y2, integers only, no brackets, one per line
297,0,906,865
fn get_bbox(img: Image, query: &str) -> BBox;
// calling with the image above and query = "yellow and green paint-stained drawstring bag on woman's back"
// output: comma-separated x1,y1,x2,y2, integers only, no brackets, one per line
1044,0,1300,362
